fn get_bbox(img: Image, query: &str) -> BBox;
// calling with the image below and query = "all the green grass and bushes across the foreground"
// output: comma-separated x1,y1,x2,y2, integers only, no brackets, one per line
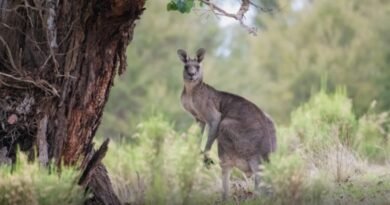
0,90,390,205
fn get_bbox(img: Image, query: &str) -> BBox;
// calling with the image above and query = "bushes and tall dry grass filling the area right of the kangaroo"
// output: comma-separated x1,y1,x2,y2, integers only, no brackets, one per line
261,89,390,204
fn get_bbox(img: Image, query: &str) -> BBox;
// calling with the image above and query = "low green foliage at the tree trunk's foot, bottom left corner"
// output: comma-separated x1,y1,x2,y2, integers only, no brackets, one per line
0,155,85,205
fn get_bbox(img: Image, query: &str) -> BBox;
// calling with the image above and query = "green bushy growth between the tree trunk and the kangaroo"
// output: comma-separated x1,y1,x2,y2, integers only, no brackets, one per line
104,114,219,204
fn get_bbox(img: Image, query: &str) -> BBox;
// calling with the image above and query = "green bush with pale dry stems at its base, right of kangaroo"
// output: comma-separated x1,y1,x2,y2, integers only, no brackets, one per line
290,89,364,181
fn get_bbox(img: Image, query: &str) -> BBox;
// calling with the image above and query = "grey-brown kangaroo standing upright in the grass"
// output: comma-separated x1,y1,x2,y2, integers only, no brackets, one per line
177,48,276,200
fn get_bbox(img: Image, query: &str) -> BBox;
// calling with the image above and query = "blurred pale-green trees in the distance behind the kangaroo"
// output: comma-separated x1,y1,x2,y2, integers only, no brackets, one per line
99,0,390,138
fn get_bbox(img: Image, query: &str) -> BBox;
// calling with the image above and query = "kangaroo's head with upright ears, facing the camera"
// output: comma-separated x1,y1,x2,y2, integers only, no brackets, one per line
177,48,206,83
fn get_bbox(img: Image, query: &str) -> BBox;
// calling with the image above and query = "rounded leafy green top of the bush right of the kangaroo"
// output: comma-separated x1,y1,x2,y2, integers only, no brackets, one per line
291,89,357,152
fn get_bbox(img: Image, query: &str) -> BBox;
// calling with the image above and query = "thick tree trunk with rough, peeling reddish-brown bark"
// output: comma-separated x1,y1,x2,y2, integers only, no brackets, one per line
0,0,145,203
